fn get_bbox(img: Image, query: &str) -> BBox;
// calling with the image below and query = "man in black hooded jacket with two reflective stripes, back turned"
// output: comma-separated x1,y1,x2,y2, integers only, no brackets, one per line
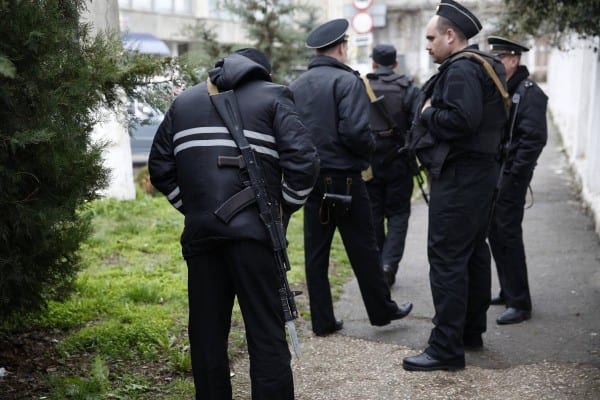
149,49,318,400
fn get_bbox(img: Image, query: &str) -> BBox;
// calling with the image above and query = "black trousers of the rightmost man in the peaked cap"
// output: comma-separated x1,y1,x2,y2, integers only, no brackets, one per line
488,172,533,311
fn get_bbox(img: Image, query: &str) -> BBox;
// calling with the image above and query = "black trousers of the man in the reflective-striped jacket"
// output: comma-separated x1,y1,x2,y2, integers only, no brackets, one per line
186,240,294,400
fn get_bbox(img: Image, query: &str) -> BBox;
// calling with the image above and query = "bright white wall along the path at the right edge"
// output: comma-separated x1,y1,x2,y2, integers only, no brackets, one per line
547,38,600,234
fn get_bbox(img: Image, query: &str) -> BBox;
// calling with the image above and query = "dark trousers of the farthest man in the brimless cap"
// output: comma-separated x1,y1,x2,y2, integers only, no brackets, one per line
367,139,414,273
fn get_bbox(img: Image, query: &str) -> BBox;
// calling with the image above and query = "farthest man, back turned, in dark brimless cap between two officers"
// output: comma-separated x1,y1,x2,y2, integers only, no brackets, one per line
367,44,419,286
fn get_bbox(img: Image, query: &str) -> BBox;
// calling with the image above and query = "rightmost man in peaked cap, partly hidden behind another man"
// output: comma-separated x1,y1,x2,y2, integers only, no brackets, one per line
488,36,548,325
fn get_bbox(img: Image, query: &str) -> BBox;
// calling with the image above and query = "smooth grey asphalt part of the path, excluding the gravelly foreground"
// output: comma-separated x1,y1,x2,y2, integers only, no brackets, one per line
336,122,600,368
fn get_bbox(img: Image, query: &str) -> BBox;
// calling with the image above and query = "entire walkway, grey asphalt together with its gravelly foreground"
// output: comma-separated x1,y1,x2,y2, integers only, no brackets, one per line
233,122,600,400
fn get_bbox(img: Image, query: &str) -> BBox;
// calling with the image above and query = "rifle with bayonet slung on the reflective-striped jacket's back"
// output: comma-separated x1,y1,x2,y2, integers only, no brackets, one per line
207,80,300,358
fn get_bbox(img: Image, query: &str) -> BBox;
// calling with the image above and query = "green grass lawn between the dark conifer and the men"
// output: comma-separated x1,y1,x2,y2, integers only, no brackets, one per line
2,193,351,400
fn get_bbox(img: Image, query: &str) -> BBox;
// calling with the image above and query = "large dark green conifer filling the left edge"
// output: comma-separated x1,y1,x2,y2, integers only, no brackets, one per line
0,0,169,320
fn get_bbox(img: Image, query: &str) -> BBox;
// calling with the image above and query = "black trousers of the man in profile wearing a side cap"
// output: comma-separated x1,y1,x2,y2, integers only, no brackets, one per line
426,155,499,365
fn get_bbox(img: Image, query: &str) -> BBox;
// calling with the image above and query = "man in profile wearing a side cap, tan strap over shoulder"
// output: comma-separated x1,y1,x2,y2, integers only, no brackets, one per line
403,0,508,371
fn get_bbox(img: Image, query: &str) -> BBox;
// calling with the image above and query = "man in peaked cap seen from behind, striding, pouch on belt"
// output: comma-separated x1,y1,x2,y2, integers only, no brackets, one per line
290,19,412,335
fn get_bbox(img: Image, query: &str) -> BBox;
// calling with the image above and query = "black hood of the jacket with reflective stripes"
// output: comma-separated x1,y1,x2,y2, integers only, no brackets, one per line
208,53,271,91
